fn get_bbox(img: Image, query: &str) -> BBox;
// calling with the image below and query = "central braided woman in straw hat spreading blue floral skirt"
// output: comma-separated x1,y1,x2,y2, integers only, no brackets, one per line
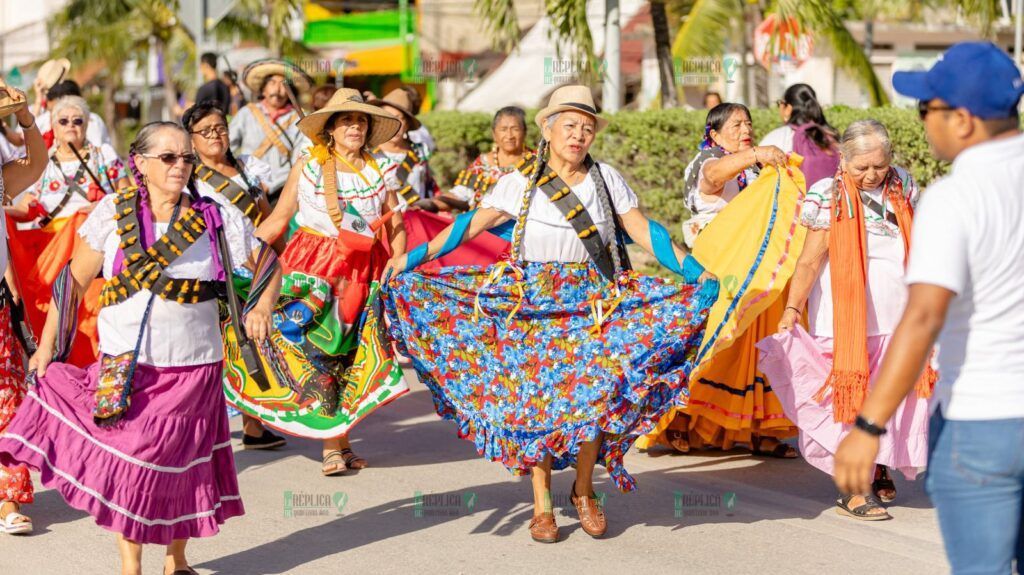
385,86,718,542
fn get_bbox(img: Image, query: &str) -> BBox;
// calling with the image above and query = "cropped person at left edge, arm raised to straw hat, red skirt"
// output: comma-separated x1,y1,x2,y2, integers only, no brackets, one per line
0,81,47,534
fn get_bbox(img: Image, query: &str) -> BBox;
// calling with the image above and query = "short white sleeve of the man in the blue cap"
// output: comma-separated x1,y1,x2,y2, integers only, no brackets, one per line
905,180,971,294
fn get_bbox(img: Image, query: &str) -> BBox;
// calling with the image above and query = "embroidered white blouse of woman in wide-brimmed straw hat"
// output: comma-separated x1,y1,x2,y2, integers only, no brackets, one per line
295,152,403,237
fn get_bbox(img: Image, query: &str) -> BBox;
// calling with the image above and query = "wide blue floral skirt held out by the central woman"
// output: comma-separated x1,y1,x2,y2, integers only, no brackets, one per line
385,262,718,491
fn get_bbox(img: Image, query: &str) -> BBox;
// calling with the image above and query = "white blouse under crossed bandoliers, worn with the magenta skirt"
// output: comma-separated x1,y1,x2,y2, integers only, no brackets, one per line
78,195,259,367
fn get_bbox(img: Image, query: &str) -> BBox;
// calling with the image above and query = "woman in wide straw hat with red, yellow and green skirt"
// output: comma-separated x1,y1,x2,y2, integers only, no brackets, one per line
249,88,408,476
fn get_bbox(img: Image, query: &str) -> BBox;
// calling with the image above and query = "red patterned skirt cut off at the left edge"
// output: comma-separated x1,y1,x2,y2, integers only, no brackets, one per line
0,306,33,503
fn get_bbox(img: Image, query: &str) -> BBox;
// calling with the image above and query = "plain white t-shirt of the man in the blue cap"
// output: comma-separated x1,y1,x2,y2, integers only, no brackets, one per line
906,135,1024,421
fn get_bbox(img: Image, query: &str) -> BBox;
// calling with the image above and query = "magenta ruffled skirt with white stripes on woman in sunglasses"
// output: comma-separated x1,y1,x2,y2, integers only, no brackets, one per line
0,362,245,544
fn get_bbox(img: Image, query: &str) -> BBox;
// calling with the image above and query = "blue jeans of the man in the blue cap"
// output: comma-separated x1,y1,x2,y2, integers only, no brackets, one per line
925,410,1024,575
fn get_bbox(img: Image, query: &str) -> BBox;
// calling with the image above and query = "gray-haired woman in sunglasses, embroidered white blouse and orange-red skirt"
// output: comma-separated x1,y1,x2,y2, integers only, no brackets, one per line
7,91,129,366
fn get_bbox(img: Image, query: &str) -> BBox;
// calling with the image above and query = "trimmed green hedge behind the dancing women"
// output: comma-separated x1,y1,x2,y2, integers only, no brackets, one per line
422,106,947,239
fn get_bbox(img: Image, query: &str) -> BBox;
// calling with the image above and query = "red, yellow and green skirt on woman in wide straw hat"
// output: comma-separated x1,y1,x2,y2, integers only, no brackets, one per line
224,229,409,439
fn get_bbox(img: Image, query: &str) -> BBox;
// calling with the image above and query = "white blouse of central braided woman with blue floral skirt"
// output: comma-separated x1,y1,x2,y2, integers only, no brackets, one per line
480,164,640,263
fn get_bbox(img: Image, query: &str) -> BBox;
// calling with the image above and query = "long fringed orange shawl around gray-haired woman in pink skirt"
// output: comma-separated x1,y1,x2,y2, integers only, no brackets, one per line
814,168,937,424
